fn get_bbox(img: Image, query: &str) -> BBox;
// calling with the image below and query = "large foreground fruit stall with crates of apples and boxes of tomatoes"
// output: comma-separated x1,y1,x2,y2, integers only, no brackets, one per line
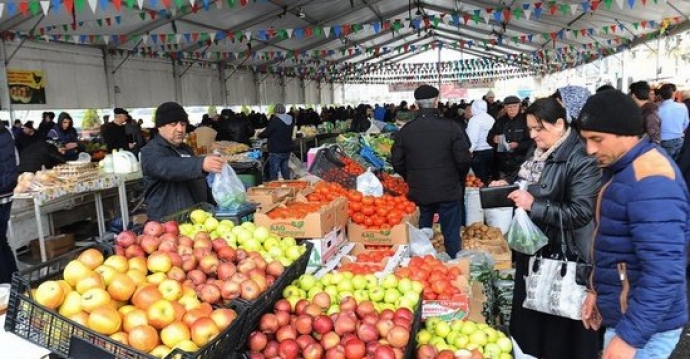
5,148,513,359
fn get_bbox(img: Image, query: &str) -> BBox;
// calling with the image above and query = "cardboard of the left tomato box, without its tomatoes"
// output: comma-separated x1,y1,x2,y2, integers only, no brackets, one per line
254,198,345,239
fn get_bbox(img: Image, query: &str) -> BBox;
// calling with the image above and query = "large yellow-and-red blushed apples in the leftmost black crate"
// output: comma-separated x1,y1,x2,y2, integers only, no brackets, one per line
32,248,237,358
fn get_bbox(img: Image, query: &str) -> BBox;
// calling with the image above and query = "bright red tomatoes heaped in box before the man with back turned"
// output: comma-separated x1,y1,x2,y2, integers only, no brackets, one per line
348,191,416,230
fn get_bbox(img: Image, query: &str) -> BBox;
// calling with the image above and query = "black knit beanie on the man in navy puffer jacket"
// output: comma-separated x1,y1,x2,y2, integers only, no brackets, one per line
578,90,644,136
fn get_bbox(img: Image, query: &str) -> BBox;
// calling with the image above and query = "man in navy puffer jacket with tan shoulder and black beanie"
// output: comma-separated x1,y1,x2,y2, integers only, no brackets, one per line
580,91,690,359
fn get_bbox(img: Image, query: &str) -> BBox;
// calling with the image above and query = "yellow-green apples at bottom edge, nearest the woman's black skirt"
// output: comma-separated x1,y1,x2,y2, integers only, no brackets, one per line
417,317,513,359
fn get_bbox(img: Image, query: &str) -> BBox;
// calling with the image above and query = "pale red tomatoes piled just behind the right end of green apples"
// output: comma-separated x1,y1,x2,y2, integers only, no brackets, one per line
395,255,462,300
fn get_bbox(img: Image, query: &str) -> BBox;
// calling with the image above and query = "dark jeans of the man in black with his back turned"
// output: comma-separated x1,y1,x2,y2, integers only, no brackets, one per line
419,201,462,258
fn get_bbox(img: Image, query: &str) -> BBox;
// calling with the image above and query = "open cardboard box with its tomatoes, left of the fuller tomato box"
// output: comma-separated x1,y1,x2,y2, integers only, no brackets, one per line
254,196,347,238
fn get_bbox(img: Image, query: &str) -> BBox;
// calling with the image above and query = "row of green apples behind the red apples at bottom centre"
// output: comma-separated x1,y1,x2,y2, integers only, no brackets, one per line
283,271,423,315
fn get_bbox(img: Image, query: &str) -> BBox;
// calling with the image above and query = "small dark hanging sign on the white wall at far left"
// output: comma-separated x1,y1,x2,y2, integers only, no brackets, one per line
7,69,46,105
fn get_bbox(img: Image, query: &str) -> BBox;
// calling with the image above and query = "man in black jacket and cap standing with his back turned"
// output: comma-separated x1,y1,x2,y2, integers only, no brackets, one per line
392,85,472,258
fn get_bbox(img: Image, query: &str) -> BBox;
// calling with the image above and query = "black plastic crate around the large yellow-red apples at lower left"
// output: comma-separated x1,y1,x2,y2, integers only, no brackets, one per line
5,244,245,359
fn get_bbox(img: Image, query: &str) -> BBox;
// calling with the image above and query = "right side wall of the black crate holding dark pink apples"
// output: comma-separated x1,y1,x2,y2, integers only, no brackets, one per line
233,242,314,350
